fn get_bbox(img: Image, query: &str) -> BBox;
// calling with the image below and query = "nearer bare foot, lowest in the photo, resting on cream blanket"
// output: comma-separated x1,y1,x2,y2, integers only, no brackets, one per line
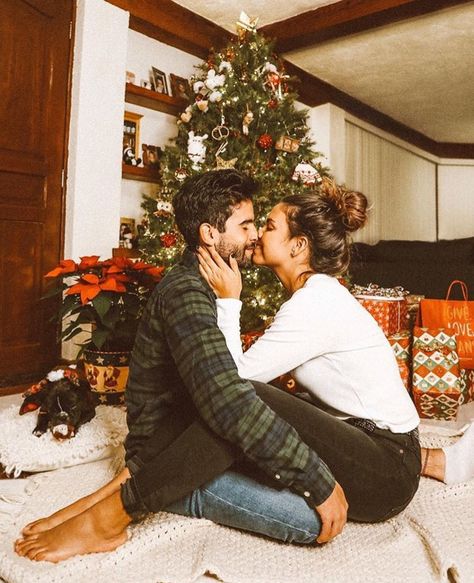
15,492,131,563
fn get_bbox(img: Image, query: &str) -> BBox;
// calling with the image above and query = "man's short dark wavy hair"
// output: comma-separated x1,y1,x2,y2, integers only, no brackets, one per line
173,169,257,249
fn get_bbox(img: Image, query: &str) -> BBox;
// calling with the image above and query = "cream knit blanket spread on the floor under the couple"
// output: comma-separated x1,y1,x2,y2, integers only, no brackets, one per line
0,434,474,583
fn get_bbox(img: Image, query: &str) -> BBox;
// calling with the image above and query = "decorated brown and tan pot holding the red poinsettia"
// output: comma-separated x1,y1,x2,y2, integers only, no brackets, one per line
84,350,131,405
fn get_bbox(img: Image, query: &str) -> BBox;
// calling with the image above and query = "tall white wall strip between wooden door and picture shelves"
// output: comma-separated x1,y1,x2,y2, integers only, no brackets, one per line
64,0,128,259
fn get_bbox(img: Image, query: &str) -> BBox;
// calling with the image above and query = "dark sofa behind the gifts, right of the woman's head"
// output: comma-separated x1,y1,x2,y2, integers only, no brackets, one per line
349,237,474,299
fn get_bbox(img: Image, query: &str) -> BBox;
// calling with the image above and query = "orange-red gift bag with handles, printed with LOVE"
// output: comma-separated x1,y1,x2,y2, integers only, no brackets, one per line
420,279,474,369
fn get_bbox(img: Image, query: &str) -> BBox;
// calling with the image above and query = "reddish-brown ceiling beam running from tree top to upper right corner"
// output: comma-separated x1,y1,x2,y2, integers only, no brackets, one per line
259,0,471,53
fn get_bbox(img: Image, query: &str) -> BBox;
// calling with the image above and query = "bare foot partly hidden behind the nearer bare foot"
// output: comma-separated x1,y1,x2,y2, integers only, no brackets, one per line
21,468,130,536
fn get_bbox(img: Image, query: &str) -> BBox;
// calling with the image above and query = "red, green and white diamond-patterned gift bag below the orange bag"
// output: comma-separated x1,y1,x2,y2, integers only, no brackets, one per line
412,326,465,420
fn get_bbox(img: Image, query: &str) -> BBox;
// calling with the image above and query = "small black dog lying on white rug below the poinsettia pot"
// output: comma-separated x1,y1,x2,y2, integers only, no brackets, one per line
20,367,95,440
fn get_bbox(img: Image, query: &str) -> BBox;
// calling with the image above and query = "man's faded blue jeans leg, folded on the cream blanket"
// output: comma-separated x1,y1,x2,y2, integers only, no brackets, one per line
166,470,321,544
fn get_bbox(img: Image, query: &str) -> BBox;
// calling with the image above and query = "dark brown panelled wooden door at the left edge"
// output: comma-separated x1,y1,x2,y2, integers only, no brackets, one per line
0,0,73,386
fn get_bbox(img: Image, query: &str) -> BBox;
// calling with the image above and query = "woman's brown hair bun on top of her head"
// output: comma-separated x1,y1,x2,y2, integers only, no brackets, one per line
320,177,368,232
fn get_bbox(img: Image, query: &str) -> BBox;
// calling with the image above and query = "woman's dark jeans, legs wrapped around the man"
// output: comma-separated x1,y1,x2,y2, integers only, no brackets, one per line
121,382,421,538
